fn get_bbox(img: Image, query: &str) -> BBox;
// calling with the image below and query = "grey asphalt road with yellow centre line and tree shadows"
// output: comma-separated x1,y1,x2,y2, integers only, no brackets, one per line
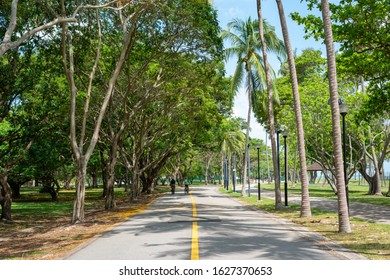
67,187,360,260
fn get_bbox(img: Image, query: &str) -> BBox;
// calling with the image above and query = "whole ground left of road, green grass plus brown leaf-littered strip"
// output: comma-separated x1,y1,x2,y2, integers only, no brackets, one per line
0,188,162,260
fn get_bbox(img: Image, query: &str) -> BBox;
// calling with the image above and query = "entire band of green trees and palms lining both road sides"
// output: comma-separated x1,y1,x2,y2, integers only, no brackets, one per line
0,0,390,232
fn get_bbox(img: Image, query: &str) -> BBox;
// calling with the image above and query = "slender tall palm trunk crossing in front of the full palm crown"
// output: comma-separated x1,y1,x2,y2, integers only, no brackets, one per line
257,0,282,209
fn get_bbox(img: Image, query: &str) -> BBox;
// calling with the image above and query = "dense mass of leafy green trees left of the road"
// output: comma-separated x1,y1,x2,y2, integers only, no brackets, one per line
0,1,240,223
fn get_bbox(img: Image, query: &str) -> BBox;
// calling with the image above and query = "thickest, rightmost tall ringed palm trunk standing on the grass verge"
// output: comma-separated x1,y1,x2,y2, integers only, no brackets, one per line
321,0,351,233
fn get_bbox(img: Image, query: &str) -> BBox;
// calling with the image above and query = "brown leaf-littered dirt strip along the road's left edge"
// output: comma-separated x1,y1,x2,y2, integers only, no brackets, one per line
0,194,159,260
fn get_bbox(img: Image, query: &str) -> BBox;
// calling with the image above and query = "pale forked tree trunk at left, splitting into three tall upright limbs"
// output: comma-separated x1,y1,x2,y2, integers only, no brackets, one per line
61,2,143,223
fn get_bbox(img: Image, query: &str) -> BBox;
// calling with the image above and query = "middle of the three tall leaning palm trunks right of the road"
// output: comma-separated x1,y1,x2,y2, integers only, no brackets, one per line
276,0,311,217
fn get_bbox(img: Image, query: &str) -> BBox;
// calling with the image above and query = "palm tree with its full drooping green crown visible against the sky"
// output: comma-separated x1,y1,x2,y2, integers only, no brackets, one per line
221,17,283,196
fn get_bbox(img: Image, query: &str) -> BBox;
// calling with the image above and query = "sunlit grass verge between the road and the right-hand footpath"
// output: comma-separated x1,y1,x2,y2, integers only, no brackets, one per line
220,188,390,260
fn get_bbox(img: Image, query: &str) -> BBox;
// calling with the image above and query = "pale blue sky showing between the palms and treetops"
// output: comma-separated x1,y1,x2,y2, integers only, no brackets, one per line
213,0,325,141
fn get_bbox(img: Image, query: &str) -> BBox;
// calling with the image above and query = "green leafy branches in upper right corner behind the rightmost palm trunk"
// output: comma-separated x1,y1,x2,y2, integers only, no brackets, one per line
293,0,390,114
